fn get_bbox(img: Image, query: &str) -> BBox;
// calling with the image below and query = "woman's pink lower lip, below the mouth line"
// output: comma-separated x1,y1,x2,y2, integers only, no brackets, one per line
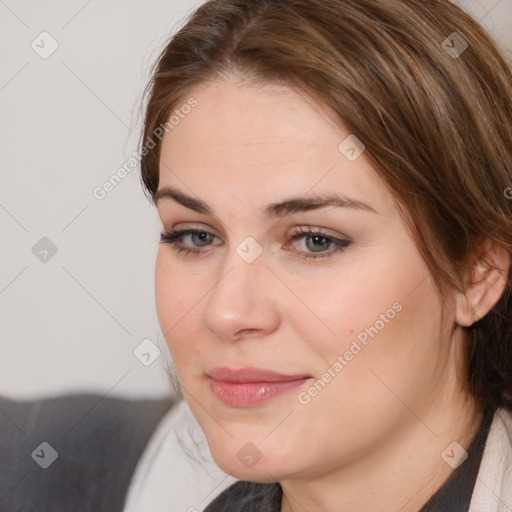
210,379,309,407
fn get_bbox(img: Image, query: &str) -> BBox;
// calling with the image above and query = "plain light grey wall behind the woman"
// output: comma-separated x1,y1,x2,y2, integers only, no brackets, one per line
0,0,512,398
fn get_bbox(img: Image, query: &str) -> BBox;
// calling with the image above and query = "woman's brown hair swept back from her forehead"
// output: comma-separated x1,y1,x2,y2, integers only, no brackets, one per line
141,0,512,411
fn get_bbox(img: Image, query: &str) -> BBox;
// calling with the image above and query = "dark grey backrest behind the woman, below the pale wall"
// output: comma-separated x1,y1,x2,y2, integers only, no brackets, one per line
0,395,173,512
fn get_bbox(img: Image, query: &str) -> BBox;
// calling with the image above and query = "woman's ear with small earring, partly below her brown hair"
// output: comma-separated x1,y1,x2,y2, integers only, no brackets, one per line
454,239,510,326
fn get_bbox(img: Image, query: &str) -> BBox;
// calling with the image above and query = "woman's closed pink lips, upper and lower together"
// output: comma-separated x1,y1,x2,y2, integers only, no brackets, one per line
207,367,311,407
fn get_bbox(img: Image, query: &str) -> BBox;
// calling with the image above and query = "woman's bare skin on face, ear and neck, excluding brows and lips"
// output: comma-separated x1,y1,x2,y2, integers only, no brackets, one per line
155,76,508,512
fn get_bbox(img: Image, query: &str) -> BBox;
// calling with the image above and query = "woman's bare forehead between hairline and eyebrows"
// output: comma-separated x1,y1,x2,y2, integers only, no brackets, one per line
159,79,392,217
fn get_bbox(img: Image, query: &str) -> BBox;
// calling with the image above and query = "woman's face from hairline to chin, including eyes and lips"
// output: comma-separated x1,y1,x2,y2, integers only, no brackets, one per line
156,79,453,482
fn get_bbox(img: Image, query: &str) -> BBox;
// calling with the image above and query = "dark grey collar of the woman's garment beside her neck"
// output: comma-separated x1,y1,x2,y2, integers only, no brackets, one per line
204,407,495,512
